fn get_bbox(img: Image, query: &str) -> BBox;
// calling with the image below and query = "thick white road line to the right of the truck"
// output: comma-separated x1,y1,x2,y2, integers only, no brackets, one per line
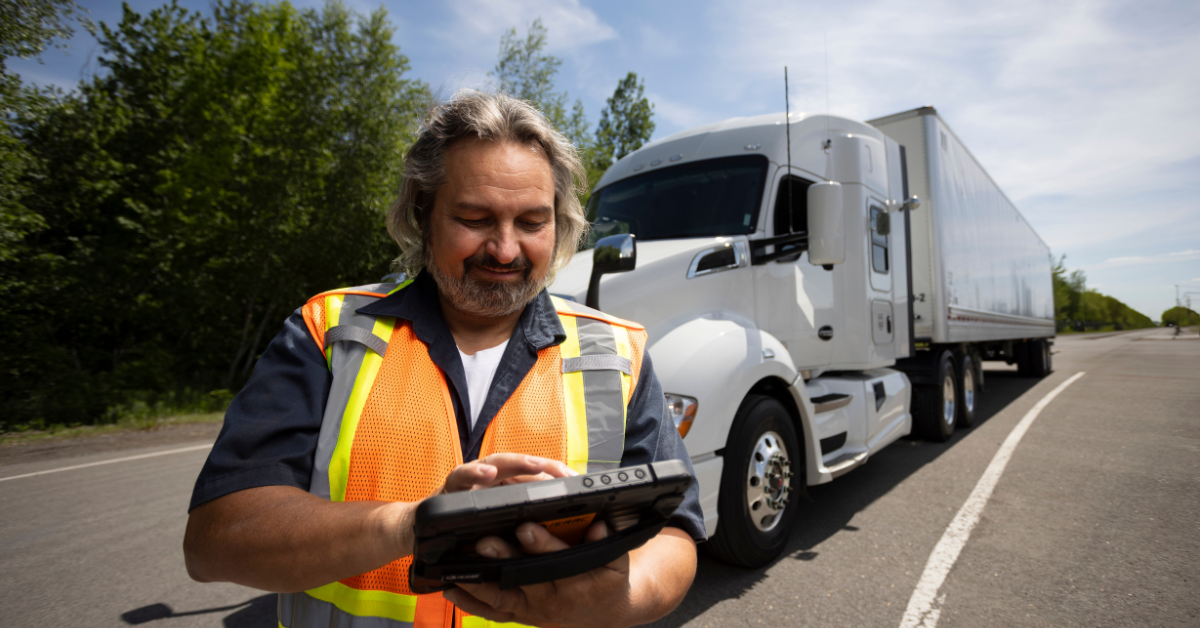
900,372,1084,628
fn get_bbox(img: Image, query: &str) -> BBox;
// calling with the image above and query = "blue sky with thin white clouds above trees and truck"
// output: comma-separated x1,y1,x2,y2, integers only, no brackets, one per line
11,0,1200,319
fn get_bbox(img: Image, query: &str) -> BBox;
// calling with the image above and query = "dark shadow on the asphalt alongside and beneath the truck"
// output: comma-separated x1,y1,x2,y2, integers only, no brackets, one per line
649,370,1040,628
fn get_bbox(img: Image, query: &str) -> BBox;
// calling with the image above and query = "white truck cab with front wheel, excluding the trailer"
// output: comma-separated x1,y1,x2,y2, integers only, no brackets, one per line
550,114,912,567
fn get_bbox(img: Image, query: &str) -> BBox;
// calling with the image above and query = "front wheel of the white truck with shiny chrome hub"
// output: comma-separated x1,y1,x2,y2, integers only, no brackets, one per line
704,395,804,568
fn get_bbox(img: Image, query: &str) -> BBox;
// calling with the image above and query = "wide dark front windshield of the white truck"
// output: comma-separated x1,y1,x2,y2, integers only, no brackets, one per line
588,155,767,249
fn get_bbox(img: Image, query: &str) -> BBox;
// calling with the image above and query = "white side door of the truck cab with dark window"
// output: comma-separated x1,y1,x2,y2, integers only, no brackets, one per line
755,168,838,369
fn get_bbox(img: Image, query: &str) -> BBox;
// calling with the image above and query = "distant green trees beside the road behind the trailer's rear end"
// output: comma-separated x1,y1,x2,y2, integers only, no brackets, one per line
1054,256,1154,333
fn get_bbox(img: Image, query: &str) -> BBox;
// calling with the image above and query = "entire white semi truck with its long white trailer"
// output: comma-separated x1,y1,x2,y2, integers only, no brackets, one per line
550,107,1055,567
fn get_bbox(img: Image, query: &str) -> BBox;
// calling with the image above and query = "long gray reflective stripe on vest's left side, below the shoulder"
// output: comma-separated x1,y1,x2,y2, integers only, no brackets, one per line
308,294,386,500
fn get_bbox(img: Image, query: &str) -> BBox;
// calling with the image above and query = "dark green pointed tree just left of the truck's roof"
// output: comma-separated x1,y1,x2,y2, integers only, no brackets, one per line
587,72,654,191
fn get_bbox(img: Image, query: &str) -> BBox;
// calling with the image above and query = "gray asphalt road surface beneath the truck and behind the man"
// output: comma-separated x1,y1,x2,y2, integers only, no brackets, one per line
0,330,1200,628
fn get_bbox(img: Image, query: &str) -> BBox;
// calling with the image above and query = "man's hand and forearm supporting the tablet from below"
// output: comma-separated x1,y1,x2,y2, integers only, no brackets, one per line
443,522,696,627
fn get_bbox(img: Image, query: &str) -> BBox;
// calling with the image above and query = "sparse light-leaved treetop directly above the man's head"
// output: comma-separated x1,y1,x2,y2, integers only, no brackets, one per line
487,18,592,151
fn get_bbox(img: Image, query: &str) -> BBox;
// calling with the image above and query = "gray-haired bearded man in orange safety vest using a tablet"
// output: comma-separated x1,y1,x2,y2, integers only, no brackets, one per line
184,92,704,628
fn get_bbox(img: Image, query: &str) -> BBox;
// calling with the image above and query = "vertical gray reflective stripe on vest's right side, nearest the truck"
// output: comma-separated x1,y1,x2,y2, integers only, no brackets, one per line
575,316,625,472
